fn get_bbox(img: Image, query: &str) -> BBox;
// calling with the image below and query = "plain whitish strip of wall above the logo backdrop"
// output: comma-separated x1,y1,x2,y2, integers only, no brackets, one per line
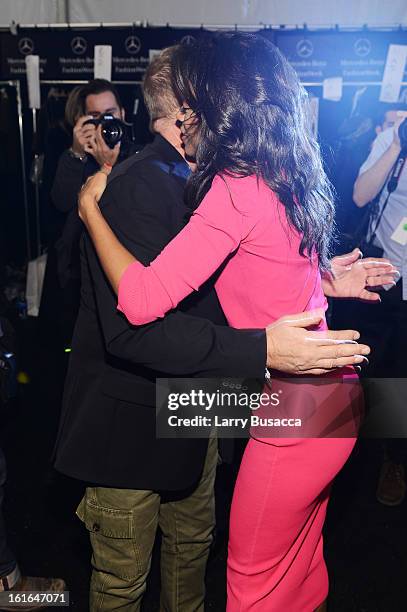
0,0,407,26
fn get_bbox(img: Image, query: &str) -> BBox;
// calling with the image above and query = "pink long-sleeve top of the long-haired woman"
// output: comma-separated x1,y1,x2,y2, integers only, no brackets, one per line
118,176,327,328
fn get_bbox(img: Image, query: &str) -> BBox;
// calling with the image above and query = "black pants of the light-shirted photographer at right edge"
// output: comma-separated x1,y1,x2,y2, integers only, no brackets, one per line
332,279,407,463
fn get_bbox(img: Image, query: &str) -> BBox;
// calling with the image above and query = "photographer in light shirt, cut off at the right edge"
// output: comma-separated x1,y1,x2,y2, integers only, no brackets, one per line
353,111,407,506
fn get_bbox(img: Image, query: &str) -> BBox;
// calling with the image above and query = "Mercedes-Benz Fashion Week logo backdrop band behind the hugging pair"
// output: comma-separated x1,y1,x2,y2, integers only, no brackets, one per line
0,27,407,83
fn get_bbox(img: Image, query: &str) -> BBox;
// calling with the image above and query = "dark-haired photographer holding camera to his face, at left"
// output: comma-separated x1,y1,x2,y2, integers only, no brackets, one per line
48,79,139,345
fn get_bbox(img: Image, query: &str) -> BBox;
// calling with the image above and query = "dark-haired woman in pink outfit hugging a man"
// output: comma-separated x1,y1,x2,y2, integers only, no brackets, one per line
77,33,361,612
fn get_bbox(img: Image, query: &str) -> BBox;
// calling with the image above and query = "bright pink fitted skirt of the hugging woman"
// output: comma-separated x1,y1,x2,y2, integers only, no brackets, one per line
227,438,356,612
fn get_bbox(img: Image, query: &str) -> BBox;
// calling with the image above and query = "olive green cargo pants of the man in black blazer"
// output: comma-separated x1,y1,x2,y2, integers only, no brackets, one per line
77,438,218,612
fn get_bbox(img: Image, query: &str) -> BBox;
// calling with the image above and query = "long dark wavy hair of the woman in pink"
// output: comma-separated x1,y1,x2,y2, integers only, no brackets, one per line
172,32,334,268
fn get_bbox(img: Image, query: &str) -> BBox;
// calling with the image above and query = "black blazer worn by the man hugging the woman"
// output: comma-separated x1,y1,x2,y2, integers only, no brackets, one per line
55,136,266,490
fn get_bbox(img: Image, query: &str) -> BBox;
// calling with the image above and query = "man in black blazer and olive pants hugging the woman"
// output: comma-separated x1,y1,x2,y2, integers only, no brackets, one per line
56,48,370,612
